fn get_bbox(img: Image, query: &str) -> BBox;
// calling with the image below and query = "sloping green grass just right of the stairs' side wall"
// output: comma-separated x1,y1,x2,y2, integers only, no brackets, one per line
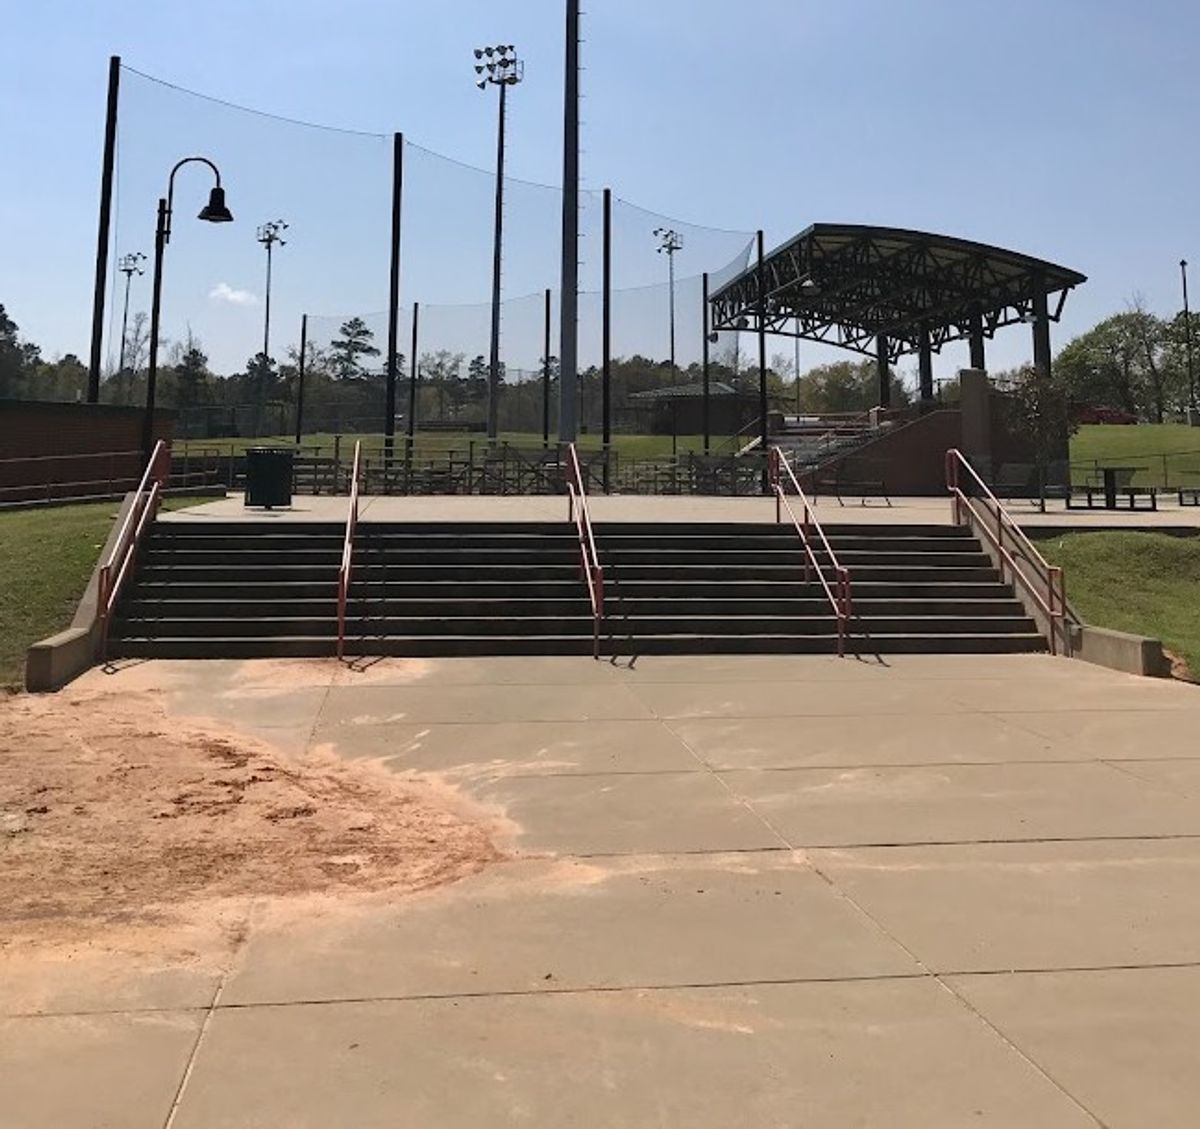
1038,533,1200,679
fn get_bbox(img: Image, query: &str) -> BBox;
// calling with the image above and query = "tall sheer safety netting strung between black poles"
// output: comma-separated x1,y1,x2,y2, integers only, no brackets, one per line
104,67,752,438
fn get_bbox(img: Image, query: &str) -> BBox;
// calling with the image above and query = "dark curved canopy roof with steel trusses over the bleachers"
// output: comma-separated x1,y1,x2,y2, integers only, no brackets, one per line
709,223,1087,360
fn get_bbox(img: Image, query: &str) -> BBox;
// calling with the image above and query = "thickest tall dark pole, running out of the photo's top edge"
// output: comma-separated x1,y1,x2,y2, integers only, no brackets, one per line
558,0,580,443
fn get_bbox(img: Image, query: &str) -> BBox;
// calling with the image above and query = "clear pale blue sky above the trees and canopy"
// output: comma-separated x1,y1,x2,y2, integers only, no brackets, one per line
0,0,1200,374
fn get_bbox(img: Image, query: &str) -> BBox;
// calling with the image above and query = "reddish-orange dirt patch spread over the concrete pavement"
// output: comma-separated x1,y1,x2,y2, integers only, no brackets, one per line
0,691,499,948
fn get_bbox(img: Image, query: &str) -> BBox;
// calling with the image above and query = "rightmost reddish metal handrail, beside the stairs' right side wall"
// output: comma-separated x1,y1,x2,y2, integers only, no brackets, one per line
946,448,1072,656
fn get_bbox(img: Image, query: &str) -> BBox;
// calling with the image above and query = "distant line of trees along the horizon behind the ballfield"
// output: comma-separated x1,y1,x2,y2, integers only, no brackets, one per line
0,302,1200,436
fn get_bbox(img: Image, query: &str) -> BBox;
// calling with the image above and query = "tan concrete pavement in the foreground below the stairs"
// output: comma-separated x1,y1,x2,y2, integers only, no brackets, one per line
0,652,1200,1129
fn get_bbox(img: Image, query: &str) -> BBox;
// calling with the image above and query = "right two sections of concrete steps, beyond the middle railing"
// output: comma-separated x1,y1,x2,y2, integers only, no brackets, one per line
595,523,1046,654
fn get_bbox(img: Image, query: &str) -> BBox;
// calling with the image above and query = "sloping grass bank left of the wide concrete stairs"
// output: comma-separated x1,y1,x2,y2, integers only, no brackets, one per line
0,499,196,692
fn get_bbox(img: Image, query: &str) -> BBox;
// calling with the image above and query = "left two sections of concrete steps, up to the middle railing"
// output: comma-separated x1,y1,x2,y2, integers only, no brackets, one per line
109,522,593,659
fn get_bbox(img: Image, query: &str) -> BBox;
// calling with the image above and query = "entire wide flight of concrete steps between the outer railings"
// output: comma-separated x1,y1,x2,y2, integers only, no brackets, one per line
109,521,1045,657
